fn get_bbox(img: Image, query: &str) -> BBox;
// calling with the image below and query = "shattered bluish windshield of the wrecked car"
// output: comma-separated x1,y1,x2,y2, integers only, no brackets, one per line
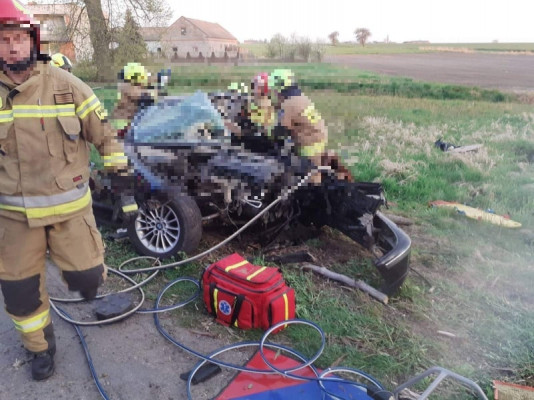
133,91,230,144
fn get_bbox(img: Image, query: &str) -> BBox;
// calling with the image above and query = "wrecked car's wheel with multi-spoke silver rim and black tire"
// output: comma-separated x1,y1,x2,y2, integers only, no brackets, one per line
127,196,202,259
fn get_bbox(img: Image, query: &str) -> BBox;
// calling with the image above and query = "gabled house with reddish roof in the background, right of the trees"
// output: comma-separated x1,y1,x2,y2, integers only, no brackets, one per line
161,16,239,59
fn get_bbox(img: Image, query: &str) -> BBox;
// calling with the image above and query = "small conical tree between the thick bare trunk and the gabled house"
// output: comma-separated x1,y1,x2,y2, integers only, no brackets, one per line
114,10,147,66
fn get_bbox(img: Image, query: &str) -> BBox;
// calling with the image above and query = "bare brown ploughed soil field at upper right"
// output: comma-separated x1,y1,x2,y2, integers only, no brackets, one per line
325,52,534,93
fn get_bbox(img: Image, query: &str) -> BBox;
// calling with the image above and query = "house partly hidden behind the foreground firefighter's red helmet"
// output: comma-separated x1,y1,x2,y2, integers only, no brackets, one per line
26,2,92,62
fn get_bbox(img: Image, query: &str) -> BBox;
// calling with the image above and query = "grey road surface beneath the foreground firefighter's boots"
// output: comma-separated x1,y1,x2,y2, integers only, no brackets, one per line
0,265,242,400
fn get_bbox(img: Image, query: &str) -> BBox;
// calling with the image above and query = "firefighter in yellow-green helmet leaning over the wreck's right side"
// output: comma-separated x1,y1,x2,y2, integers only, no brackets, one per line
269,69,328,183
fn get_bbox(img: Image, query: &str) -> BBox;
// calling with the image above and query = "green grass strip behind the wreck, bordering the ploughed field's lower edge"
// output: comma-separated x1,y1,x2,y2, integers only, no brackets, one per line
95,64,519,109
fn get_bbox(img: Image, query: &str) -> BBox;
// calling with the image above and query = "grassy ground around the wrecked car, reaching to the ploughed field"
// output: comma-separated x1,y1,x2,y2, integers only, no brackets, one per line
97,64,534,400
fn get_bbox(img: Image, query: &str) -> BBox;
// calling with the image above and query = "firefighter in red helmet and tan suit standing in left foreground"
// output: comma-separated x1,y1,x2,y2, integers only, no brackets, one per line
0,0,137,380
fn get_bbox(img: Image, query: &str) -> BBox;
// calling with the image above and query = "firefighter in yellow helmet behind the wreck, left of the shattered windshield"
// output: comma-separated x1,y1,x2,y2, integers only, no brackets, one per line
111,62,157,137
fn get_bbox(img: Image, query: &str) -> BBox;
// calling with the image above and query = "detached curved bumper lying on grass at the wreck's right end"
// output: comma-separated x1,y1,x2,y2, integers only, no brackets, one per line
373,211,412,295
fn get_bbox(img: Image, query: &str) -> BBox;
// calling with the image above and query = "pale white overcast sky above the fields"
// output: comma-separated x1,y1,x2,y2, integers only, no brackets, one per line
167,0,534,43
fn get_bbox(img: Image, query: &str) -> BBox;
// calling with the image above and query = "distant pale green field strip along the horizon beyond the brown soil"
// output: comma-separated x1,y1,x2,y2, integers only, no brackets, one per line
242,43,534,58
